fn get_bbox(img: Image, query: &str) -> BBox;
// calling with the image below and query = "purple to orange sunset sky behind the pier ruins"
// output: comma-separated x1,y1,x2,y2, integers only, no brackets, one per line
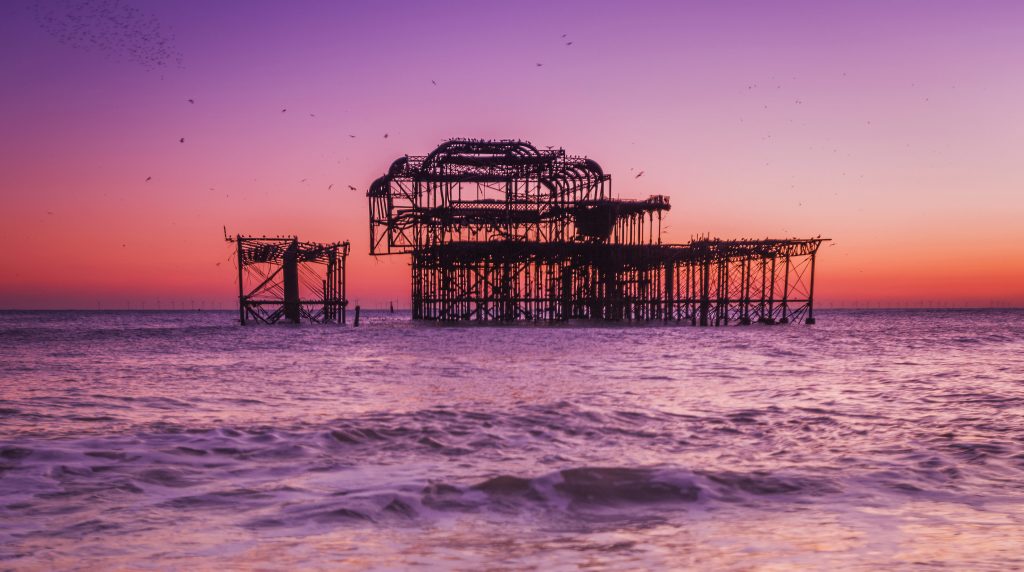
0,0,1024,308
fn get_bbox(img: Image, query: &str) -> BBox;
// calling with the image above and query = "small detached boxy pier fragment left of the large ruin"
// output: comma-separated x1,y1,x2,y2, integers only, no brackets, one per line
226,234,350,325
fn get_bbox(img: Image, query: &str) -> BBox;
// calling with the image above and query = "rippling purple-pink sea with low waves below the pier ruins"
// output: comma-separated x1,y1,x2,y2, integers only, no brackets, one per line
0,309,1024,570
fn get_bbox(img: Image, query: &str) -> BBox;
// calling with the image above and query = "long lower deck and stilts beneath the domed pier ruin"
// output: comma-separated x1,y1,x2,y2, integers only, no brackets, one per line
413,239,820,325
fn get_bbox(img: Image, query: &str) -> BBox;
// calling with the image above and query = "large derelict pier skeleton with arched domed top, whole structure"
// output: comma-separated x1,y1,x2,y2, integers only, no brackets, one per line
368,139,822,325
